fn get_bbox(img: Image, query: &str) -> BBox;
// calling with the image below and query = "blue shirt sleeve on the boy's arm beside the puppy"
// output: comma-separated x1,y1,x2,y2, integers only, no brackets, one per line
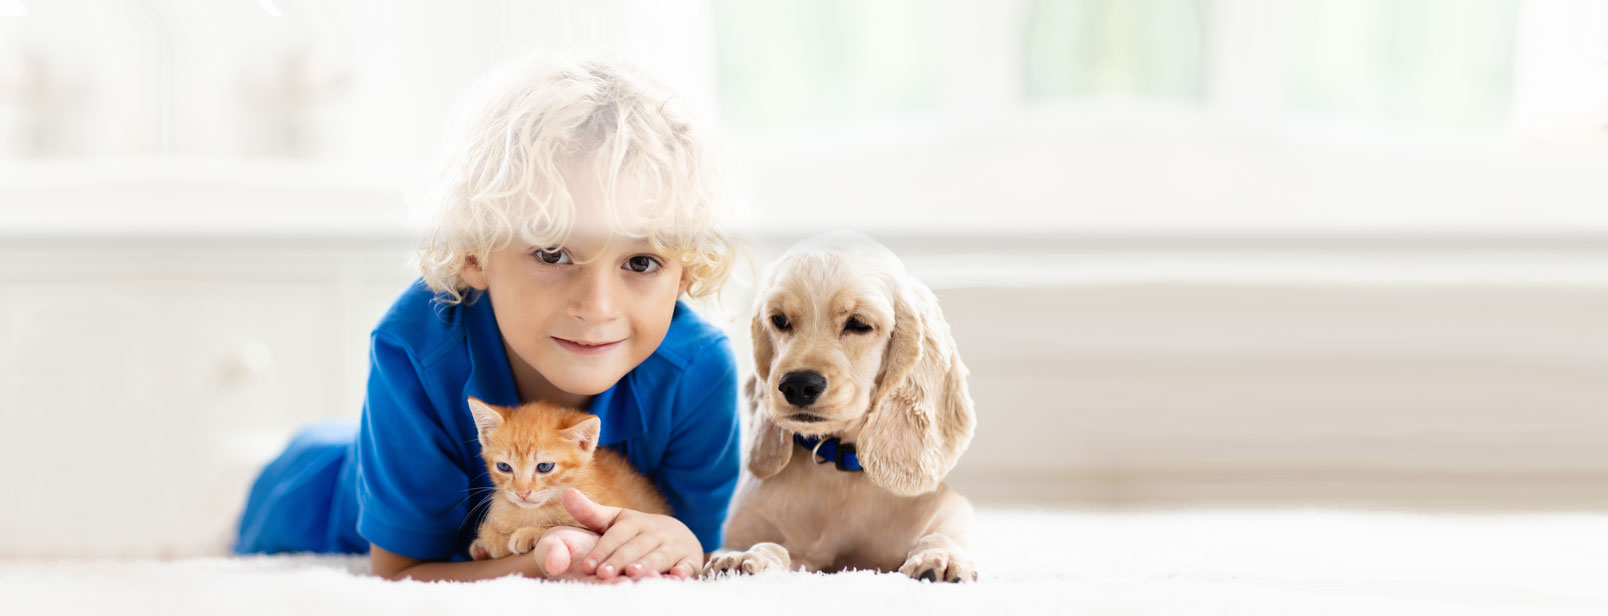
658,338,741,552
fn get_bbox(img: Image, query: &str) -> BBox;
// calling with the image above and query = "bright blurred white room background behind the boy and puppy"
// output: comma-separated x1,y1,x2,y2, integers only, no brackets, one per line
0,0,1608,558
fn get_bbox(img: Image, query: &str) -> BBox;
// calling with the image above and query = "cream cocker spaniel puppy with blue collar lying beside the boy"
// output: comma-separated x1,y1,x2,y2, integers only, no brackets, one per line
708,233,978,582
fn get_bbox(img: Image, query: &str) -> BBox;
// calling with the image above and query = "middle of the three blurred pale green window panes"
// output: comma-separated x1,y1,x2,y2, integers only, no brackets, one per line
1024,0,1209,100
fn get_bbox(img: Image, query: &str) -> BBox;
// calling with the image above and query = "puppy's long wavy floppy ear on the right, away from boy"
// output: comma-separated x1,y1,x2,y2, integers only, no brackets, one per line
855,277,976,495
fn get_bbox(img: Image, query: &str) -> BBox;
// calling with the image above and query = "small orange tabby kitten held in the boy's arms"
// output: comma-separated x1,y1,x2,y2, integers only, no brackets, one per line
470,397,671,558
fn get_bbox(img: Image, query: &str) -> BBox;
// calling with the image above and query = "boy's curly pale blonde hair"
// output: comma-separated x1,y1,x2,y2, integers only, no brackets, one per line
418,56,736,304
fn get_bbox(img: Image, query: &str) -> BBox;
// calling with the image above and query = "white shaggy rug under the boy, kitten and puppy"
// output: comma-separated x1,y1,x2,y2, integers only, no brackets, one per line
0,510,1608,616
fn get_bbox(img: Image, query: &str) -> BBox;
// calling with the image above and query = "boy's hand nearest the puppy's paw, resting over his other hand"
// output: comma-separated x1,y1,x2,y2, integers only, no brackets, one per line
563,489,703,581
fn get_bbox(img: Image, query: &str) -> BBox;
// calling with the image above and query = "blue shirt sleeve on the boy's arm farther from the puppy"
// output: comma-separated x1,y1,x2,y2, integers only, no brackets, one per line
357,335,470,560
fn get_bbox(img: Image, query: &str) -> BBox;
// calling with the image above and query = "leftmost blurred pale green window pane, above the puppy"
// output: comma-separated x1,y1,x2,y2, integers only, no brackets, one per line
714,0,944,129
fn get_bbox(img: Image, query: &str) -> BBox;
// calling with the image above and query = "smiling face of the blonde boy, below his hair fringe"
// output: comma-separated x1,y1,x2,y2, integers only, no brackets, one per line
463,232,683,407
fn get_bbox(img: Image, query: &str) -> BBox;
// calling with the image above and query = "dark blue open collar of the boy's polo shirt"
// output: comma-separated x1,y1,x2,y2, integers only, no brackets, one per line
458,290,646,446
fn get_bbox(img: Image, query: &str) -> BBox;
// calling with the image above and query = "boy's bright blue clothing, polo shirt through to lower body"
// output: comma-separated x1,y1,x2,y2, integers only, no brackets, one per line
235,281,740,560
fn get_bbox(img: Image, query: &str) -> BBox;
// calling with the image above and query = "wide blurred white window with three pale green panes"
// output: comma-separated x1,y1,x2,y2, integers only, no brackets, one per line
714,0,1520,133
